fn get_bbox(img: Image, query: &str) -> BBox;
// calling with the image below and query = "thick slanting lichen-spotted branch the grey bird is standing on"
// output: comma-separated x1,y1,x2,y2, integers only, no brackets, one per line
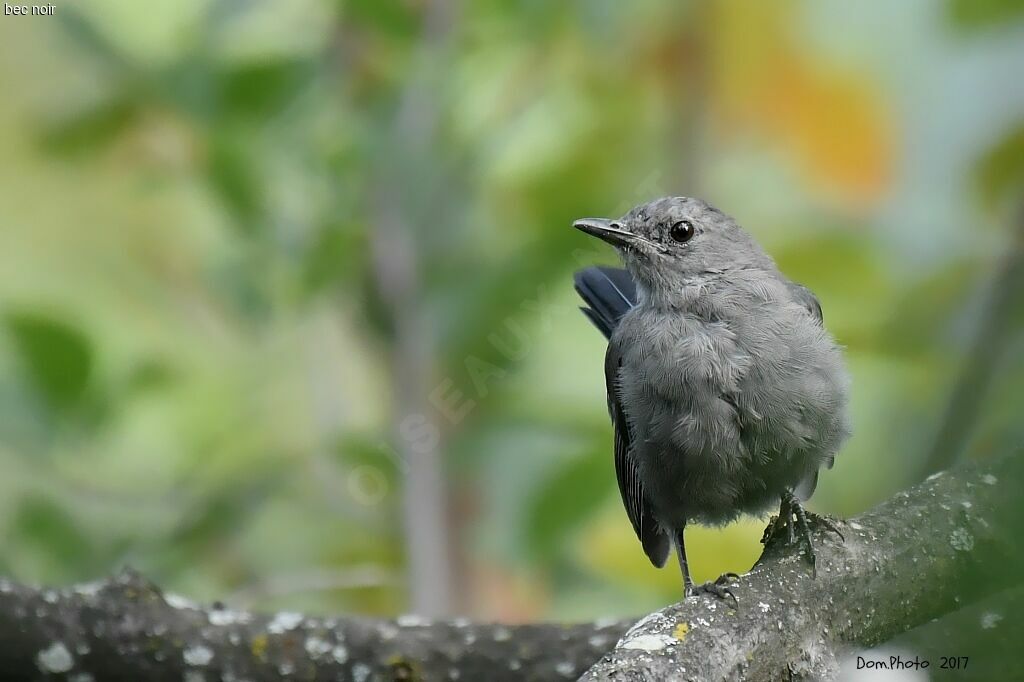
582,456,1024,682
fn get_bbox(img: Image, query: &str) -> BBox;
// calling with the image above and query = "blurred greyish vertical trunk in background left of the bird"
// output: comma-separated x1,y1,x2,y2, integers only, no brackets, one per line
371,0,457,616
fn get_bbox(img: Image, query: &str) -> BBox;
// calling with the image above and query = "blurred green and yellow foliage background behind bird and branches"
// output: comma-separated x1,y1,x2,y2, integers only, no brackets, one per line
0,0,1024,653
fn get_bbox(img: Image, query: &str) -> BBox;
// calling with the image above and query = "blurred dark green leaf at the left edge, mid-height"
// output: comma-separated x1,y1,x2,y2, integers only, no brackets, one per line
6,312,93,411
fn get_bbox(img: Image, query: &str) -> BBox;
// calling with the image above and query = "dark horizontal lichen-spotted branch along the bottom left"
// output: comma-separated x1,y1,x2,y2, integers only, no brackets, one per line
0,570,628,682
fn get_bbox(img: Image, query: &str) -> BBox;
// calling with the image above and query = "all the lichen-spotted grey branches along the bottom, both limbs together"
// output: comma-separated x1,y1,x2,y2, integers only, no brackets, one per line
0,448,1024,682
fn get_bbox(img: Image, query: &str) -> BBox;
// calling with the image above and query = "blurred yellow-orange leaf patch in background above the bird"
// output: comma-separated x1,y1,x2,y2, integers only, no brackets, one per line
710,0,894,205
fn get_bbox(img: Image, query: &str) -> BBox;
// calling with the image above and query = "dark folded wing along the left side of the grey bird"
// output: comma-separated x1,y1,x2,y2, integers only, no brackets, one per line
604,333,669,568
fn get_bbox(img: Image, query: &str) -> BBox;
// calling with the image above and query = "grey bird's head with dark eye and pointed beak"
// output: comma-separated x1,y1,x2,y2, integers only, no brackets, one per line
572,197,773,293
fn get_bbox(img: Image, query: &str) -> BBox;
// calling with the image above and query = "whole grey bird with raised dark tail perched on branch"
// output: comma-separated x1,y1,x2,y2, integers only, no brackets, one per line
573,197,849,597
